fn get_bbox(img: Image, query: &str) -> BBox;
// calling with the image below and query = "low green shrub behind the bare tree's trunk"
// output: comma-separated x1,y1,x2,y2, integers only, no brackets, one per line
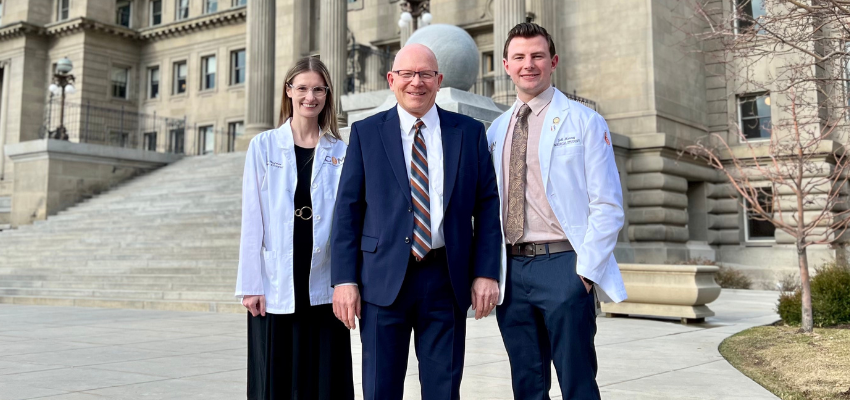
776,263,850,327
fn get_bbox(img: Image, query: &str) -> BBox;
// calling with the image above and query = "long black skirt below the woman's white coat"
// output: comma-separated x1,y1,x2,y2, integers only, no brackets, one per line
248,304,354,400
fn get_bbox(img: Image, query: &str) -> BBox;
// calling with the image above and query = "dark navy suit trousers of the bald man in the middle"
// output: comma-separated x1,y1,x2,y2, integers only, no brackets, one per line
360,249,466,400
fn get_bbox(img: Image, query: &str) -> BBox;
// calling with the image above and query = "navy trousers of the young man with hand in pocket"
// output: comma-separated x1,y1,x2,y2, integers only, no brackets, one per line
496,251,600,400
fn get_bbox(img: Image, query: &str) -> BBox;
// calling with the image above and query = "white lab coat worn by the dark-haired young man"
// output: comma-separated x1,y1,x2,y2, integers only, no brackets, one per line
487,90,626,304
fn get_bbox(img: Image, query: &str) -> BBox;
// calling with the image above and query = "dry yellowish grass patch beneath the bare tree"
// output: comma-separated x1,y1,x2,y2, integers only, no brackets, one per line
720,326,850,400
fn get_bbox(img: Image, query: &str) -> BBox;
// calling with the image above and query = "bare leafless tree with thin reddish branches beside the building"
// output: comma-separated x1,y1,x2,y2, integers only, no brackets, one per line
682,0,850,332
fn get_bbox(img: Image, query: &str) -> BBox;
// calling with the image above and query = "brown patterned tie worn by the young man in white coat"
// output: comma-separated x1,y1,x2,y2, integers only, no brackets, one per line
505,104,531,244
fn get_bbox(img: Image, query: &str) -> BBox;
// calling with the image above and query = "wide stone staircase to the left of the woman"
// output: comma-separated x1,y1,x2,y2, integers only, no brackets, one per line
0,153,245,312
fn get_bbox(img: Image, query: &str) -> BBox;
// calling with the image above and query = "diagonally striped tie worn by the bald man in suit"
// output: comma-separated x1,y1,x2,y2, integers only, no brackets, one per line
410,119,431,261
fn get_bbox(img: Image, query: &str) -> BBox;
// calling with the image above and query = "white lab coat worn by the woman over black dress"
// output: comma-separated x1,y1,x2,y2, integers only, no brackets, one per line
236,121,348,314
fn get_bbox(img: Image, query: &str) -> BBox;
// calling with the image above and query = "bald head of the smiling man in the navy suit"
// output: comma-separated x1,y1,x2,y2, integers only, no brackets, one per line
387,43,443,118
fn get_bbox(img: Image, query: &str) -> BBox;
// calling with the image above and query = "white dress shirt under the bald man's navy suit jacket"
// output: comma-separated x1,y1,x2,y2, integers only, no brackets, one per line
396,105,446,249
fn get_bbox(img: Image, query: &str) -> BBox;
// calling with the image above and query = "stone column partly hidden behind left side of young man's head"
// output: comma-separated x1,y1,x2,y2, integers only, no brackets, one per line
493,0,525,104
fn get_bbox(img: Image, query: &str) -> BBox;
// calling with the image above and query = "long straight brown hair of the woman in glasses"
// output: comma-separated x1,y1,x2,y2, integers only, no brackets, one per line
278,56,342,140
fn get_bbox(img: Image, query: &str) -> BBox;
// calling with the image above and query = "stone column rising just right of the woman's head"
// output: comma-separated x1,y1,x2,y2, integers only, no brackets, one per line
319,0,348,126
